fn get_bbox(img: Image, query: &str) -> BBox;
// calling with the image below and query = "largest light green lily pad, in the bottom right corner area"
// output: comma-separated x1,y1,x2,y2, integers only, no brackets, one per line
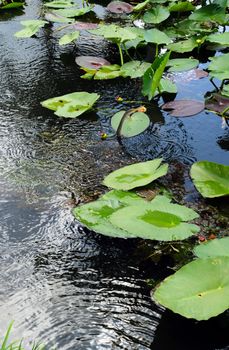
154,257,229,320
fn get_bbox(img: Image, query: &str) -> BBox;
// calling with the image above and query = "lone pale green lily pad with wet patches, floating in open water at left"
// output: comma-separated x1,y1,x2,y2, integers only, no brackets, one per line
41,91,100,118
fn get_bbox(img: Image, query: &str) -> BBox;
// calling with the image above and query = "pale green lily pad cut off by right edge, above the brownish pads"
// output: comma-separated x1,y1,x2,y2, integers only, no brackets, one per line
208,53,229,80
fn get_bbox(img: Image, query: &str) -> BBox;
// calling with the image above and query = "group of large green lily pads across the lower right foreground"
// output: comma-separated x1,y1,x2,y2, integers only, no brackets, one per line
73,158,229,320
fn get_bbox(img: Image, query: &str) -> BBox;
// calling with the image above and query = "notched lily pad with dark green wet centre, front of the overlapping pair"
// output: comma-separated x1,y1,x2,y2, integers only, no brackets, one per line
110,196,199,241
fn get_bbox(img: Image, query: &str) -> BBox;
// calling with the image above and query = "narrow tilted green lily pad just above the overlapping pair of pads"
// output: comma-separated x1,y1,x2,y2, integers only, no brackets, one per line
103,158,168,191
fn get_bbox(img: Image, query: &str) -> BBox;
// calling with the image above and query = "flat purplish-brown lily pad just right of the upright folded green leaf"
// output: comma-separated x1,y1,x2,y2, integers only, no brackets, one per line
162,100,204,117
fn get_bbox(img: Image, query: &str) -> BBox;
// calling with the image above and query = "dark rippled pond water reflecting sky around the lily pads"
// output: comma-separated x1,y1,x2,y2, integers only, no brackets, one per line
0,0,229,350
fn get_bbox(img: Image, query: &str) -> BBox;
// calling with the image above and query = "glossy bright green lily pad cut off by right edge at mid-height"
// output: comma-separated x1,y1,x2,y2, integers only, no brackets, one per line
190,161,229,198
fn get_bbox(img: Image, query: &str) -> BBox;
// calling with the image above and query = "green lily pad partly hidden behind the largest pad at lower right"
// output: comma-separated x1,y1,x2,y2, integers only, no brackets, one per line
194,237,229,259
